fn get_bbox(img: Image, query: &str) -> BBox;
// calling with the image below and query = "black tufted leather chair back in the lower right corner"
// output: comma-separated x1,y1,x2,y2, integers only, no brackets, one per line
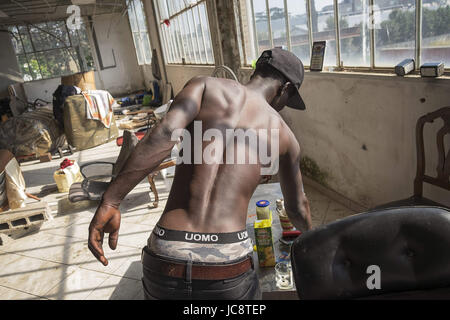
291,207,450,299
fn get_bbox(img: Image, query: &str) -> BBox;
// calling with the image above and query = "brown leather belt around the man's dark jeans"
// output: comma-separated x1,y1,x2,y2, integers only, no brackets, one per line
142,249,253,280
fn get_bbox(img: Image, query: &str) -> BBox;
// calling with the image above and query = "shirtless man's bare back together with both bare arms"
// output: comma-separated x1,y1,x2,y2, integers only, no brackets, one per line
89,70,311,265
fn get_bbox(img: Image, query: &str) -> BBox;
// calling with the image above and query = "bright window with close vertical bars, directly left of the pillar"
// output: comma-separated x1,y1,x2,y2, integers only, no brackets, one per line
155,0,214,64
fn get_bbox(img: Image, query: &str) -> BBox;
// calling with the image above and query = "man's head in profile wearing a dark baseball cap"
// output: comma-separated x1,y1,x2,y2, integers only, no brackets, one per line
251,48,305,111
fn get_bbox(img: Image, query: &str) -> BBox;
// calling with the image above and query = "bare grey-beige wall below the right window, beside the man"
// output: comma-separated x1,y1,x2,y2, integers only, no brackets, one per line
264,72,450,207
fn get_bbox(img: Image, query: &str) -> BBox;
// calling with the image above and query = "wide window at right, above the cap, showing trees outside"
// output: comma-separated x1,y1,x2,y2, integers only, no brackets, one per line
234,0,450,69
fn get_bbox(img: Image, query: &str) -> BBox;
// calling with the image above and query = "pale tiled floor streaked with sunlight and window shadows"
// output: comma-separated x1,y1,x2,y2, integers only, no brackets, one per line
0,141,356,300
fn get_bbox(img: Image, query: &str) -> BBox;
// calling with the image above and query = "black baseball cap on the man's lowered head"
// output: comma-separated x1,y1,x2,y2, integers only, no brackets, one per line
256,48,306,110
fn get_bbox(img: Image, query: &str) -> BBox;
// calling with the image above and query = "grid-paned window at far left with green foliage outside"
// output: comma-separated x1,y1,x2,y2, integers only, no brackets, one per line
9,21,94,81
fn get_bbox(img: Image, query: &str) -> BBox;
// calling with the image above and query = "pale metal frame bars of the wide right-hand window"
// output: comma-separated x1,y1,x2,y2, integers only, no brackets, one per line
239,0,450,73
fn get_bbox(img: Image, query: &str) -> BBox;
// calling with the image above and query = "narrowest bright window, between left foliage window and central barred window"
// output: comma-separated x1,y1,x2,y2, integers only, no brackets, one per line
128,0,152,65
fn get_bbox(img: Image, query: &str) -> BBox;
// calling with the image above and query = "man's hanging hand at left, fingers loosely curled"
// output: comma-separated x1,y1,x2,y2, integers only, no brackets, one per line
88,202,120,266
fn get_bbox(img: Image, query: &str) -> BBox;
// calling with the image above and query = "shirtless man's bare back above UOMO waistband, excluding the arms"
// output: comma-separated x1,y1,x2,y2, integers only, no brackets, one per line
158,77,300,232
